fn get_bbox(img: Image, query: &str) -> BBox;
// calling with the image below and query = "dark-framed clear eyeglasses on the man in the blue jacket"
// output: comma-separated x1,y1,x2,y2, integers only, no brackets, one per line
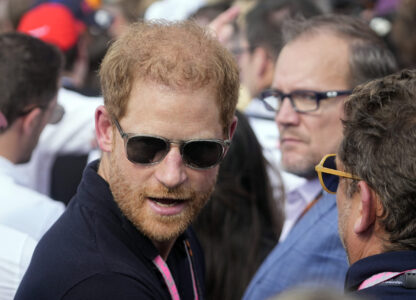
260,89,351,112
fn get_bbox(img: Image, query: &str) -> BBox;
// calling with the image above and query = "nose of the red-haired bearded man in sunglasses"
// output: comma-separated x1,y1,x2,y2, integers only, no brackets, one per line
155,145,188,189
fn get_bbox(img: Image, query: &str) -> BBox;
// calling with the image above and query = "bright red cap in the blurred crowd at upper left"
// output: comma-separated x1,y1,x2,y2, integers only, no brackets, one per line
17,3,85,51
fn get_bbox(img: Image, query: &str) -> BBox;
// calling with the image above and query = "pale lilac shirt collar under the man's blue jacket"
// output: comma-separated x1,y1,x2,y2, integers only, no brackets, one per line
279,178,322,242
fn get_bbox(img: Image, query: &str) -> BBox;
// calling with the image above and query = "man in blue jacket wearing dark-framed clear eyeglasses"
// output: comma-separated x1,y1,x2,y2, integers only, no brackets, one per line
244,15,395,299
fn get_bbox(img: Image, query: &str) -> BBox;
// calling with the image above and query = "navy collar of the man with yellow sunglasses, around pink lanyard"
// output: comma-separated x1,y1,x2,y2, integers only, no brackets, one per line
345,251,416,300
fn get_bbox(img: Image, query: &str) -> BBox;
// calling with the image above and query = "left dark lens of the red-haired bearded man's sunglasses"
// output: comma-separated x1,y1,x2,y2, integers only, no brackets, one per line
127,136,169,164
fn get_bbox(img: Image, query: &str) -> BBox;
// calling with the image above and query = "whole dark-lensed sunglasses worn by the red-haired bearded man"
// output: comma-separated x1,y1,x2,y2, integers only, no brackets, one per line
114,118,231,169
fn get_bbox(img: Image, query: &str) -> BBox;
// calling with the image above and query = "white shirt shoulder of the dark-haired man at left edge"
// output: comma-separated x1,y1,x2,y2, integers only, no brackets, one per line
0,156,65,240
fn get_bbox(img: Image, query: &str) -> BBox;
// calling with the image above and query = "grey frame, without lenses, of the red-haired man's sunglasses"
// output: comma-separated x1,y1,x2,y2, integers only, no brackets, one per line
112,117,231,170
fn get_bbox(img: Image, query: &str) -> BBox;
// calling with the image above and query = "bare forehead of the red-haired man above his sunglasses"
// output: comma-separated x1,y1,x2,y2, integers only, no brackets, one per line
123,81,222,139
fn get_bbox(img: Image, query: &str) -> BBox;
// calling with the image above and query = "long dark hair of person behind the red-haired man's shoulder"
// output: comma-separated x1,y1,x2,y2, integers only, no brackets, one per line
194,112,283,300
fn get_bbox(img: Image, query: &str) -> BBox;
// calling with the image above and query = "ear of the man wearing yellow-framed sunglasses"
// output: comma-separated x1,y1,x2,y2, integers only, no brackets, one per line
354,181,377,234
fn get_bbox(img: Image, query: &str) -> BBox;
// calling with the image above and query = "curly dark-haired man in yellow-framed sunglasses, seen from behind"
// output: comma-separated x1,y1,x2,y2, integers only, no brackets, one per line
316,70,416,299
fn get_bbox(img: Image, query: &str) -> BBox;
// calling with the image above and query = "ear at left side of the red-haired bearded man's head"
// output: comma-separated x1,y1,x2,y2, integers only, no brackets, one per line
95,105,113,152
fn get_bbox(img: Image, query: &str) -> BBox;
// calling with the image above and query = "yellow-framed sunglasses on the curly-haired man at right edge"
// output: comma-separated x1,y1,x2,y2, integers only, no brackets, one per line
315,154,361,194
